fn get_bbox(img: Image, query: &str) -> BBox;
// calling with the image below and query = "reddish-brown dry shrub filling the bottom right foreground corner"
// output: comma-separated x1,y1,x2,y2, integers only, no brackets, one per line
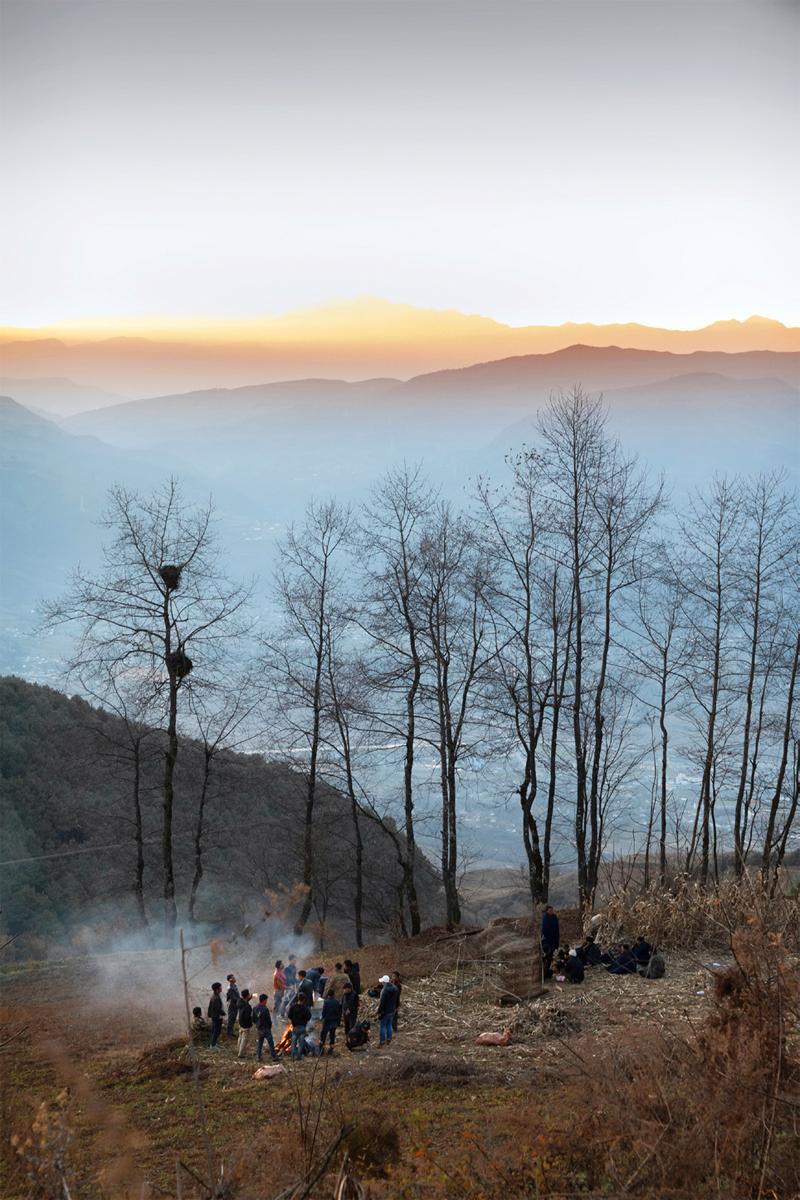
494,905,800,1200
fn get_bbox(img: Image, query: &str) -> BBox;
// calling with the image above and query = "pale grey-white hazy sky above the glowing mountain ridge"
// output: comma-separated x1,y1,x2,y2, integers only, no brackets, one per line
0,0,800,326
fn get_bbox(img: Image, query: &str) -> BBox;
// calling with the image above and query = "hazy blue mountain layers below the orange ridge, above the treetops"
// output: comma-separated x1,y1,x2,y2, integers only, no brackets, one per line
0,333,800,678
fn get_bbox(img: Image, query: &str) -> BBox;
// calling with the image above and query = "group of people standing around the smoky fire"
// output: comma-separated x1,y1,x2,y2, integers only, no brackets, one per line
192,954,402,1062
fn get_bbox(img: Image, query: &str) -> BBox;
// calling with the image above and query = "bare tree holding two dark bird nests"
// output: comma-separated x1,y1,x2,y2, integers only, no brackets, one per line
46,479,249,937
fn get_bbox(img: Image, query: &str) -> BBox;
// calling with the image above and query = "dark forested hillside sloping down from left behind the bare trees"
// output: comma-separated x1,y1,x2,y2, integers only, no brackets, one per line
0,677,438,955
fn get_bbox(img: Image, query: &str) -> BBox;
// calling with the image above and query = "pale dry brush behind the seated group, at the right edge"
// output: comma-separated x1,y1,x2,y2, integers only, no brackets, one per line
602,876,800,949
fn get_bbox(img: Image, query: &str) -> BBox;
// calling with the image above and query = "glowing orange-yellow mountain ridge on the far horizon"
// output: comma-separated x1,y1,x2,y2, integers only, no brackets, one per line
0,299,800,396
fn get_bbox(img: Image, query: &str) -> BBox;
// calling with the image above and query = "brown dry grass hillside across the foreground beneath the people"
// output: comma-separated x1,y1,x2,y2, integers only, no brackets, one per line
0,888,800,1200
